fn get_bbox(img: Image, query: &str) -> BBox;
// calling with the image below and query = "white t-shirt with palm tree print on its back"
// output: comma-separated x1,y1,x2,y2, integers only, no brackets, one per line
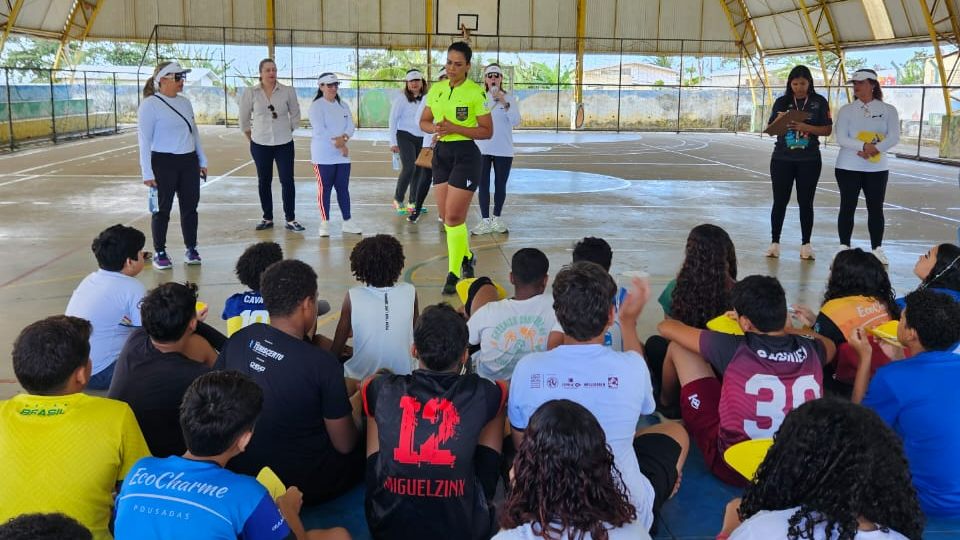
467,294,557,381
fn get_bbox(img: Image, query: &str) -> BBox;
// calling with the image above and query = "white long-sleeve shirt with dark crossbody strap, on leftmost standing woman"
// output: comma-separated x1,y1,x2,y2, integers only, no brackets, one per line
137,94,207,181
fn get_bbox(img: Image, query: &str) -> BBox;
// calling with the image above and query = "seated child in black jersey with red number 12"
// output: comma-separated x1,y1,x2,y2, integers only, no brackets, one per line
362,304,507,540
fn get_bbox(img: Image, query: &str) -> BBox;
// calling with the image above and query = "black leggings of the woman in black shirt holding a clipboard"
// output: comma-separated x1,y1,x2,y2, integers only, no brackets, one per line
770,159,823,244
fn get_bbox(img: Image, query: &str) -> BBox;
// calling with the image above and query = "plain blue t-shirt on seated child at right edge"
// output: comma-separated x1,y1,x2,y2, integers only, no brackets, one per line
863,351,960,517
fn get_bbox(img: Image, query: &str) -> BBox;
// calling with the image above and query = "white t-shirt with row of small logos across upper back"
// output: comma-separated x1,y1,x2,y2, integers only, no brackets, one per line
507,345,656,529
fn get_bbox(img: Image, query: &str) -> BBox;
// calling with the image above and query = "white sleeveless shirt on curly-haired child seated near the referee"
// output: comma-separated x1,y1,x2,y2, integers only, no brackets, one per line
343,283,417,379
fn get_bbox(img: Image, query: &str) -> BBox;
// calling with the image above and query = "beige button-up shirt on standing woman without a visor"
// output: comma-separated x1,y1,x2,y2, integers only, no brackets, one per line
240,83,300,146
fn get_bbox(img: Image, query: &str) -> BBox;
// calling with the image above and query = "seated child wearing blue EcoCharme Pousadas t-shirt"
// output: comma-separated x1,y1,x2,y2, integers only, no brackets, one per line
115,371,350,540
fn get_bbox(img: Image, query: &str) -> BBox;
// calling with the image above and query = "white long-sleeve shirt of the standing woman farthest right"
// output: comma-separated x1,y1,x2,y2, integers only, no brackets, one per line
833,99,900,172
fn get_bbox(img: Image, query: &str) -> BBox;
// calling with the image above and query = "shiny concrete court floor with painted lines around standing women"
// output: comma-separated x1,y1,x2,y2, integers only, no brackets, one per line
0,127,960,399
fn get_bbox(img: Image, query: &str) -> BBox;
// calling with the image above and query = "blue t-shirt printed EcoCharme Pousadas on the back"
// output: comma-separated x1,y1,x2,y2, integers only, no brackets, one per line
115,456,292,540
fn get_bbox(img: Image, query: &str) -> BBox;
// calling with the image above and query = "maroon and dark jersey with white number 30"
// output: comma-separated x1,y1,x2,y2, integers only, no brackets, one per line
700,330,826,453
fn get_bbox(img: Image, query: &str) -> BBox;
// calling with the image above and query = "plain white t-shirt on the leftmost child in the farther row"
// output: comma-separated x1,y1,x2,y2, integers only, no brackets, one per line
65,269,147,375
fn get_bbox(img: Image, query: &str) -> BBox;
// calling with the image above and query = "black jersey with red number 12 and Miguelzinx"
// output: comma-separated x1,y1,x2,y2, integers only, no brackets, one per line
363,370,506,540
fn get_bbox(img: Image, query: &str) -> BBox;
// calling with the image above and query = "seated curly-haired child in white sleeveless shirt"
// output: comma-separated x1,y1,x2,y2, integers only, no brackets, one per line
332,234,420,379
